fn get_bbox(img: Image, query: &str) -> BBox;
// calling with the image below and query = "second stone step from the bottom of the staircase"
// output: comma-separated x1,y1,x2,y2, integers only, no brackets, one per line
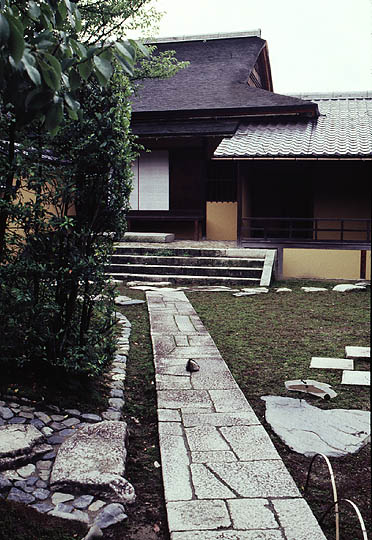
110,264,262,278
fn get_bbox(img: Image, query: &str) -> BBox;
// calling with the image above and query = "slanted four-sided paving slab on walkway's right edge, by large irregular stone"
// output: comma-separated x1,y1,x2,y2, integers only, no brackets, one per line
220,426,280,460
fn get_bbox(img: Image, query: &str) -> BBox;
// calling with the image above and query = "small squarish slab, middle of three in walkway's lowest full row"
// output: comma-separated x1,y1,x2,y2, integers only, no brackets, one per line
227,499,279,530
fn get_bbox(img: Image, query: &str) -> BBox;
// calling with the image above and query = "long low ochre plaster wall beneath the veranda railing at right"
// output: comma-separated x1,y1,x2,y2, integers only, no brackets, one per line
283,248,371,279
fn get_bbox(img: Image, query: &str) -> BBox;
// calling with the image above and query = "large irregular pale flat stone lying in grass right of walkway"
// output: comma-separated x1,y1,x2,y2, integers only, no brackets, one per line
262,394,371,457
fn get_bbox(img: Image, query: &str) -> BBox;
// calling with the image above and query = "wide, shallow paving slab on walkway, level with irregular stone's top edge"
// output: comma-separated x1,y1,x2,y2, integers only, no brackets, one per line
182,412,260,427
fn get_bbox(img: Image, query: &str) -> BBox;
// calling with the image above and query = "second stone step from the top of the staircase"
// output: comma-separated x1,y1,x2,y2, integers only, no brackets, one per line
111,254,264,268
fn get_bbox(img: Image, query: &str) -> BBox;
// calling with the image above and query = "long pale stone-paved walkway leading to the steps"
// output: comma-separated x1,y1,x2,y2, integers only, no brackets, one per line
147,291,325,540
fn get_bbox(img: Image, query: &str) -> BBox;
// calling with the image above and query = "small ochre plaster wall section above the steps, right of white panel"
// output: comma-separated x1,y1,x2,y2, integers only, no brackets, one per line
207,202,238,240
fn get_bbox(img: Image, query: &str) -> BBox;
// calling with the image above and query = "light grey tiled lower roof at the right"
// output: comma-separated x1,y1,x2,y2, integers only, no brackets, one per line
214,93,372,158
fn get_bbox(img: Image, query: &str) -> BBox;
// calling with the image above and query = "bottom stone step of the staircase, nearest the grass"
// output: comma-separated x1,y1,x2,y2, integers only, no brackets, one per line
106,272,260,286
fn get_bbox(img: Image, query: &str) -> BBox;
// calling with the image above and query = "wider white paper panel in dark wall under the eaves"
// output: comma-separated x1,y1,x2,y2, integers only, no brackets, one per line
139,150,169,210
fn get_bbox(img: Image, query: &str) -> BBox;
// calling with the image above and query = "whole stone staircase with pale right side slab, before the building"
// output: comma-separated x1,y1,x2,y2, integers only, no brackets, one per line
108,242,276,287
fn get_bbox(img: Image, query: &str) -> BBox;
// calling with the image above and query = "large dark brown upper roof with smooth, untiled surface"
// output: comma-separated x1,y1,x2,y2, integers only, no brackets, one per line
132,36,316,118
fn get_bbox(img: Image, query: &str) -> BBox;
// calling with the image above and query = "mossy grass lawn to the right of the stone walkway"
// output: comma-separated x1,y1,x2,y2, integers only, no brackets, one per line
188,281,371,540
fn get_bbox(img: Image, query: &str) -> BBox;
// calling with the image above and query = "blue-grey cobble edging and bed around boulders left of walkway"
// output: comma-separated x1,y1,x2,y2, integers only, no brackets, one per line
0,312,131,534
